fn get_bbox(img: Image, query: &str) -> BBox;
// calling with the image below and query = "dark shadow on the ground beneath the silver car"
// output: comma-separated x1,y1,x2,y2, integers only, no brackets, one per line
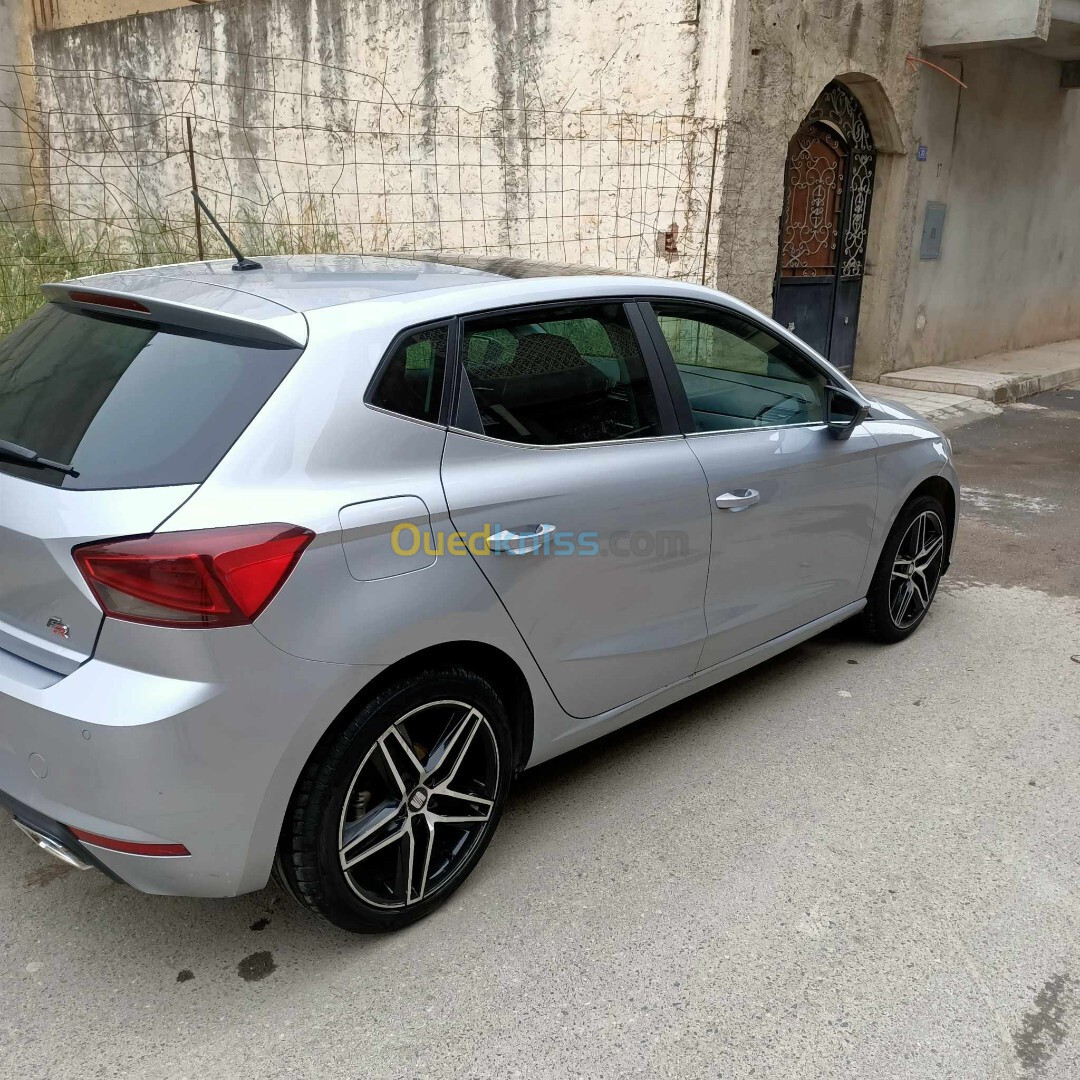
0,609,868,983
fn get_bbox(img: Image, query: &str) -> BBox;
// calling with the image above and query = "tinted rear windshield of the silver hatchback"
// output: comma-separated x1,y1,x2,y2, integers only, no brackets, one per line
0,303,301,490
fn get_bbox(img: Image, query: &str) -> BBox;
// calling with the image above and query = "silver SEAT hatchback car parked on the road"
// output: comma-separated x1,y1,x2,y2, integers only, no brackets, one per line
0,256,957,931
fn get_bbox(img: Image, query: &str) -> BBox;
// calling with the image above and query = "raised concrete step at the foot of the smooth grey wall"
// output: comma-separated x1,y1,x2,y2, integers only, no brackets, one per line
880,340,1080,404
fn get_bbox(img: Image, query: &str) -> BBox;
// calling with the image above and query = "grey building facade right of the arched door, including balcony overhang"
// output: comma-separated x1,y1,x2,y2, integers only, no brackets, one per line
894,0,1080,367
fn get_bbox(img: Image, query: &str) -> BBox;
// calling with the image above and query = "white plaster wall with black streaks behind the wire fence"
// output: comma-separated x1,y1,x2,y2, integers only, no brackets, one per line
29,0,730,273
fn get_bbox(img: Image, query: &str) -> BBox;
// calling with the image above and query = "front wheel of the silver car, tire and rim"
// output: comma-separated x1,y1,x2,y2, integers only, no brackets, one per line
861,495,949,644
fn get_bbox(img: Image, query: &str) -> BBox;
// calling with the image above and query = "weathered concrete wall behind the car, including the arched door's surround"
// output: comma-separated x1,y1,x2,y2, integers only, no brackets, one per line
19,0,920,377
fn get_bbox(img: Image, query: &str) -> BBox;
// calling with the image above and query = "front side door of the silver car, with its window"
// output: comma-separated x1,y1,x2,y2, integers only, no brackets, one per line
643,299,877,667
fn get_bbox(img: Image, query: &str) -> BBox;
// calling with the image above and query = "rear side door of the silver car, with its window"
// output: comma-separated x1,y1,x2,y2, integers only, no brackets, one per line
442,300,711,717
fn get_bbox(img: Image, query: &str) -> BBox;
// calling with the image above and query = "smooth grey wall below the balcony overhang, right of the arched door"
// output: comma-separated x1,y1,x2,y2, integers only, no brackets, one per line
897,49,1080,367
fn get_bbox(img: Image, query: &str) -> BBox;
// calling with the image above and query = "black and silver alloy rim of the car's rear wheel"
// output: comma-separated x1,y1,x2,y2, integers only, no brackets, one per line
338,701,501,907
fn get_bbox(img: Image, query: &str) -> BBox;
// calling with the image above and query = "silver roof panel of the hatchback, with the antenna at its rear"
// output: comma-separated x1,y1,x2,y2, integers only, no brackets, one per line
59,255,630,311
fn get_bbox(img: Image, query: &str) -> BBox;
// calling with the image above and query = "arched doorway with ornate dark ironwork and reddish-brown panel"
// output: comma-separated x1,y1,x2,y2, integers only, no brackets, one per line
773,82,877,373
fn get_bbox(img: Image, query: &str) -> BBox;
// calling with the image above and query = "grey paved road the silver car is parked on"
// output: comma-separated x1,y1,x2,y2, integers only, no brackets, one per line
0,390,1080,1080
